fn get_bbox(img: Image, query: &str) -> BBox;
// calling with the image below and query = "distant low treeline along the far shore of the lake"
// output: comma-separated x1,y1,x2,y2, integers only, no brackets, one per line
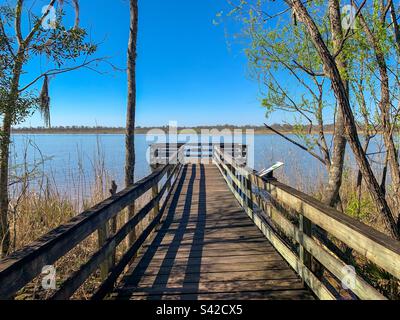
12,124,340,134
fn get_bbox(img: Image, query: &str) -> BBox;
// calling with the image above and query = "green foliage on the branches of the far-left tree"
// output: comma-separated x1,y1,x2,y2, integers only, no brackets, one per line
0,5,97,125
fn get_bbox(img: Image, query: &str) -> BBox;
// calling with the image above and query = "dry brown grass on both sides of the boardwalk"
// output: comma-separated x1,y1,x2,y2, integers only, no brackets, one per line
10,140,400,299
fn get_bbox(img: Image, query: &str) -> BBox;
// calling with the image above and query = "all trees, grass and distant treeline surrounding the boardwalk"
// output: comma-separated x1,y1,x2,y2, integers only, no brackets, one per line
0,0,400,299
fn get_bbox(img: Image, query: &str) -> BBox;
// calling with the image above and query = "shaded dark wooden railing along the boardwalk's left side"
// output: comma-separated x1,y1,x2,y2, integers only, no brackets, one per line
0,148,183,299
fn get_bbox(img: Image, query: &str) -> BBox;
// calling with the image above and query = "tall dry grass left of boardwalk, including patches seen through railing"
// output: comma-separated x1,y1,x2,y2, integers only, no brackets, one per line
10,138,155,299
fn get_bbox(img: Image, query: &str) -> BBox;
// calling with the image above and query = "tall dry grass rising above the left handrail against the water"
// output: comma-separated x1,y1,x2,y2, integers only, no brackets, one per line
10,139,113,250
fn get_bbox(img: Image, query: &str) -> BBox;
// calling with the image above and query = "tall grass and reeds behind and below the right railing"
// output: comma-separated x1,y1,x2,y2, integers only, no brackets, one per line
260,147,400,300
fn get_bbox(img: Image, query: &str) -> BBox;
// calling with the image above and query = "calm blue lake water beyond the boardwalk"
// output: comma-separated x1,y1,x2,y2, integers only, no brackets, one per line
11,134,384,198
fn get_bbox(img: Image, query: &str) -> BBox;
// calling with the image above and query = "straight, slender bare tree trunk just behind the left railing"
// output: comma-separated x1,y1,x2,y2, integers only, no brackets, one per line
125,0,138,247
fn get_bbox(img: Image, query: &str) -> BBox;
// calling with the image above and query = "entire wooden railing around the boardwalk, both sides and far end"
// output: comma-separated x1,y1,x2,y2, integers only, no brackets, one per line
0,144,400,299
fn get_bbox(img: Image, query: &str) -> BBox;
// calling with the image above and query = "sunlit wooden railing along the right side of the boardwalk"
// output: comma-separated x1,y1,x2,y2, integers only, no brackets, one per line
213,146,400,299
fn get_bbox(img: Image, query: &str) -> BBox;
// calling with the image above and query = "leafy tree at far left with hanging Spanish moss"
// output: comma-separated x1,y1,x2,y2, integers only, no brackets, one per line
0,0,102,256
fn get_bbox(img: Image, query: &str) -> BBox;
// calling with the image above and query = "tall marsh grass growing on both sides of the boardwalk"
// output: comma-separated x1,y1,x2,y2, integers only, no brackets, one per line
10,140,400,300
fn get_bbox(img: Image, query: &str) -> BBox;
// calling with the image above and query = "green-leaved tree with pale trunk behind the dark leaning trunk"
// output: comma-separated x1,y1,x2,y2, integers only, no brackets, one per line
228,0,346,208
